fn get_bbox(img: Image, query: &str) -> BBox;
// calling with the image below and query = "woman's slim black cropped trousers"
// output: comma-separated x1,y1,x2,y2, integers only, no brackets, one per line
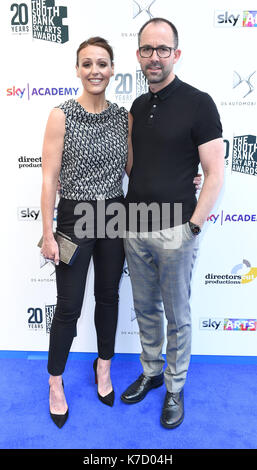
48,198,125,375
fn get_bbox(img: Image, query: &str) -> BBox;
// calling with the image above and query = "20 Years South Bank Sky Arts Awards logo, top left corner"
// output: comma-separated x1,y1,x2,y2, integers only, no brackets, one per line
10,0,69,44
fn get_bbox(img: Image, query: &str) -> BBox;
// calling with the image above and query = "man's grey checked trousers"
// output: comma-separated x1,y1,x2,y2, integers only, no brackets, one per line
124,223,199,393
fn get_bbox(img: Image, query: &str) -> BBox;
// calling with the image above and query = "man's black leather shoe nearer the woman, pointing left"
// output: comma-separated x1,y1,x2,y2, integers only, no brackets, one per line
121,373,163,403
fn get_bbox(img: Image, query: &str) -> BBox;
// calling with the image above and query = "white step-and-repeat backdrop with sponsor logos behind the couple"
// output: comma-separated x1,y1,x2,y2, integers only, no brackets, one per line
0,0,257,356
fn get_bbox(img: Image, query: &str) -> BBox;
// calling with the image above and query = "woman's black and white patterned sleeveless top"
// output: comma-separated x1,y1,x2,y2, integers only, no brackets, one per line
57,99,128,201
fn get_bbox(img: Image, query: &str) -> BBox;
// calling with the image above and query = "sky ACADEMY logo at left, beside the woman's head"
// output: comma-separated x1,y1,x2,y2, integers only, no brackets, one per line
6,83,79,100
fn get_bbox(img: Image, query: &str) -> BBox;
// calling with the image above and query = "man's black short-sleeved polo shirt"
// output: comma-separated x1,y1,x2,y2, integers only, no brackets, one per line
126,77,222,230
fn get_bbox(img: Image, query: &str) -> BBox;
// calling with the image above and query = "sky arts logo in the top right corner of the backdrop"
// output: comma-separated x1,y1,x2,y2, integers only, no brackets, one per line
214,10,257,28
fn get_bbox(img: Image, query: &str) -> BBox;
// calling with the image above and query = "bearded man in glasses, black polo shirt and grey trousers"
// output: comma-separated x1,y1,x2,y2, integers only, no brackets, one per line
121,18,224,428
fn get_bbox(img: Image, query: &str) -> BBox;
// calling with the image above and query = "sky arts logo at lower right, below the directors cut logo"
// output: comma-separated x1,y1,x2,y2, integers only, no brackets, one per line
199,318,257,331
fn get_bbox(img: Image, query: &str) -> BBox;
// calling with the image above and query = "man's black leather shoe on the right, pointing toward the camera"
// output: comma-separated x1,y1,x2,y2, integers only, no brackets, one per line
161,390,184,429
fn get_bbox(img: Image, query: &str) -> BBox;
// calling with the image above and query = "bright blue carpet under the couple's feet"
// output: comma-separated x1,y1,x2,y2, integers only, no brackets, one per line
0,352,257,449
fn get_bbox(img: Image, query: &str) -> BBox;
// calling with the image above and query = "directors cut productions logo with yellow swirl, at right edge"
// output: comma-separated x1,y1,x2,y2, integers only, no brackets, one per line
205,259,257,285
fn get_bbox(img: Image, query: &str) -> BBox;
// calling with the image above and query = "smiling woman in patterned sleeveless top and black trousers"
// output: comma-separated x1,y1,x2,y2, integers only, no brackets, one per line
41,37,200,427
